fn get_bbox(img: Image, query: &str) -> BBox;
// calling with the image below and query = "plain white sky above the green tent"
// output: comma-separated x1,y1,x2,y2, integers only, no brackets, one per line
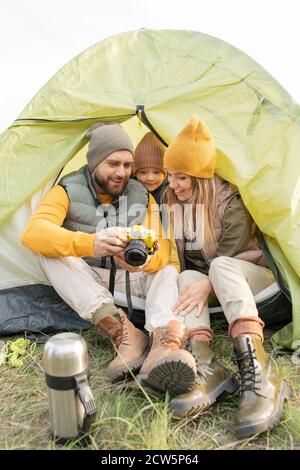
0,0,300,132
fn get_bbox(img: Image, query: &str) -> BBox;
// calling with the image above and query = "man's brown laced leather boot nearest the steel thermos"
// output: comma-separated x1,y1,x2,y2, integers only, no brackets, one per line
96,309,149,382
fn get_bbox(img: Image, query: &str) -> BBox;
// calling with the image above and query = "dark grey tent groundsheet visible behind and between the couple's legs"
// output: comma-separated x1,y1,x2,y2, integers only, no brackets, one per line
0,284,291,336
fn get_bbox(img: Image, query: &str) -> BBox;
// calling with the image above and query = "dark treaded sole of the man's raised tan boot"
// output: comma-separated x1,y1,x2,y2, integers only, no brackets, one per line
138,361,196,395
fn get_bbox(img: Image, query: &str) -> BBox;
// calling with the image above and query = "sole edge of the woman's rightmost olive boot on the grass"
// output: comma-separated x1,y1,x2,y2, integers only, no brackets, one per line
234,382,290,439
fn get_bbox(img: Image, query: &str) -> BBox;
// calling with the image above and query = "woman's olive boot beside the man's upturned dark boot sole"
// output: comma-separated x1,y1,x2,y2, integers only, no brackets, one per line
170,340,238,418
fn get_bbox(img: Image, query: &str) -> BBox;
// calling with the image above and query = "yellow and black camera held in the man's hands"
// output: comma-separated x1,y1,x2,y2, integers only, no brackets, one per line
120,225,157,266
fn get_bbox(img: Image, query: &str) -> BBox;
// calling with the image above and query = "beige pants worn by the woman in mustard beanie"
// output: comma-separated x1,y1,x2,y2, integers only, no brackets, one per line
178,256,274,328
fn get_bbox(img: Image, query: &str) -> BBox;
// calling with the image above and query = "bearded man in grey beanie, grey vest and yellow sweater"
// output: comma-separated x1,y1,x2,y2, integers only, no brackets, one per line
21,123,196,390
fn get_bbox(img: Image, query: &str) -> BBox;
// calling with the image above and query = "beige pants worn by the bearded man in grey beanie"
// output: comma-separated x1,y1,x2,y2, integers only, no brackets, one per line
40,256,184,332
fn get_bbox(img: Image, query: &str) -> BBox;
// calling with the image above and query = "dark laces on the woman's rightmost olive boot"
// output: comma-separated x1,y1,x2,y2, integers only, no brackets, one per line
234,349,264,397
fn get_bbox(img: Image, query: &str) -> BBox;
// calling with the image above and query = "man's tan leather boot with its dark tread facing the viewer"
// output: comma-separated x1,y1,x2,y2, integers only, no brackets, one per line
138,320,196,395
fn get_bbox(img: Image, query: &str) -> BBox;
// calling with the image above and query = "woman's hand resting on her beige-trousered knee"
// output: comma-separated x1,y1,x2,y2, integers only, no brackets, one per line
172,278,212,317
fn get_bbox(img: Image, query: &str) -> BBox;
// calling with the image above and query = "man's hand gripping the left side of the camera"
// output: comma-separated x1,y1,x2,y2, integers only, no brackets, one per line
94,227,128,258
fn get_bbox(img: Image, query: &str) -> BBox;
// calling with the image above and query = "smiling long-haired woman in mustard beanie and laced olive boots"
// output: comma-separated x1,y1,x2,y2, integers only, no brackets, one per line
164,116,288,437
